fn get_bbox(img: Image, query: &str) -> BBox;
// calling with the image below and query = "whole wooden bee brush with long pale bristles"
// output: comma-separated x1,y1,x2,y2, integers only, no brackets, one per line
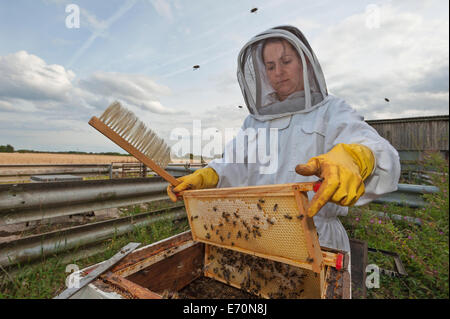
89,102,180,187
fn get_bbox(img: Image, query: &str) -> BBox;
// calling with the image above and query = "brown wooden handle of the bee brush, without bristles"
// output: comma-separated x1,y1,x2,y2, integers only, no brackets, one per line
89,116,181,187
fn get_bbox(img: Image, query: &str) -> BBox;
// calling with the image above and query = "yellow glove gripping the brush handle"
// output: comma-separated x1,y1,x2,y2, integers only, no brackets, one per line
167,167,219,202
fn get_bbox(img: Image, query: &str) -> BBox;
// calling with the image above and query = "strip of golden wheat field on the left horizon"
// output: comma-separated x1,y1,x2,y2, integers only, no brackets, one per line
0,153,137,165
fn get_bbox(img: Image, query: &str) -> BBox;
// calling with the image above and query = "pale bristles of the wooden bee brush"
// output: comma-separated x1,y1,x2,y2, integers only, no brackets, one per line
99,102,170,168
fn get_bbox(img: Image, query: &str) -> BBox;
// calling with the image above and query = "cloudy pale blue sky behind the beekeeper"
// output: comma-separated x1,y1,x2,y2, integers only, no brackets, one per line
0,0,449,152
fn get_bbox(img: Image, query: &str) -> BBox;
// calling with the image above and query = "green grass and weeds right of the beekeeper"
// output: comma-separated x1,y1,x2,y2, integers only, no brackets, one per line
341,154,449,299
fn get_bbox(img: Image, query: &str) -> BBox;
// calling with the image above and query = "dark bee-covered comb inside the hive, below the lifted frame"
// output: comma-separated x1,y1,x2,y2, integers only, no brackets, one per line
206,246,317,299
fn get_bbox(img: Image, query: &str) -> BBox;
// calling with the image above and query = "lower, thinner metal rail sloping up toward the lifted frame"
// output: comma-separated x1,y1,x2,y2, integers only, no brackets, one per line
0,207,186,266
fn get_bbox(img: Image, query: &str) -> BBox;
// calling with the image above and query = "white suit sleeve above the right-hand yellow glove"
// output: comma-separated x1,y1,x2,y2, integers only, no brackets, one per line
325,100,400,206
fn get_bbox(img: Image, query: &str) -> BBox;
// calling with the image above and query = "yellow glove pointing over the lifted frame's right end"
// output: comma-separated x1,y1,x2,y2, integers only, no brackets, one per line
295,144,375,217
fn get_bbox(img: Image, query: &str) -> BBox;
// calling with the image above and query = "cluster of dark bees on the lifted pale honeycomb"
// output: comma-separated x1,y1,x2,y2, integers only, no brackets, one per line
190,198,304,246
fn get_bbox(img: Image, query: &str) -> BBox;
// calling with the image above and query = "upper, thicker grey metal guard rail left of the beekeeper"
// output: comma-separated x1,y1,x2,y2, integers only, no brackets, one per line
0,177,168,225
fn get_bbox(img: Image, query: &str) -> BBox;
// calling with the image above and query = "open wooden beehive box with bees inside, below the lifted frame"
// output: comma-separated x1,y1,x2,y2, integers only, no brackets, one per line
73,231,350,299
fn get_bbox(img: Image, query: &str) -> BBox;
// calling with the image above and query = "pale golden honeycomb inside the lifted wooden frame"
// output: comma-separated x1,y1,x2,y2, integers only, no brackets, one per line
184,190,312,266
